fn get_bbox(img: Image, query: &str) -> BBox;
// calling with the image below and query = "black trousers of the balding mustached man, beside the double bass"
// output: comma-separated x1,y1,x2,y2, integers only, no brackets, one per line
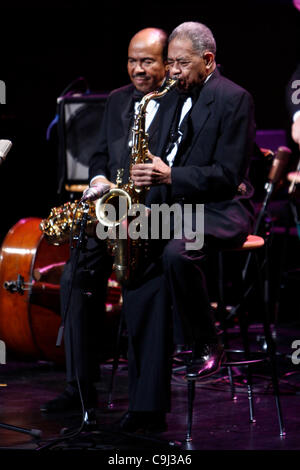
60,238,112,387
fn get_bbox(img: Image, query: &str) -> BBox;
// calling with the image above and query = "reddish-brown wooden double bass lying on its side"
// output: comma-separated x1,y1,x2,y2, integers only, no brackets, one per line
0,217,121,364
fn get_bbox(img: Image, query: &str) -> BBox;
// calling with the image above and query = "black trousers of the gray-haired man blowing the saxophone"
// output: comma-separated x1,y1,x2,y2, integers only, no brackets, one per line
123,239,216,411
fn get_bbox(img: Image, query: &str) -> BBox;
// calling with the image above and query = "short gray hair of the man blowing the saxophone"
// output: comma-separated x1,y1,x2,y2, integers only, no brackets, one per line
169,21,217,56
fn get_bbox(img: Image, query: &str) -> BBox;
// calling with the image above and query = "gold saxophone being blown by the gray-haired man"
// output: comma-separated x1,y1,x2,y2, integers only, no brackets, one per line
96,78,178,285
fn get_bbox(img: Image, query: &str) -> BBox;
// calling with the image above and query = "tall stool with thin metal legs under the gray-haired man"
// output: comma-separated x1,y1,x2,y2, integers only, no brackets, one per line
185,235,285,442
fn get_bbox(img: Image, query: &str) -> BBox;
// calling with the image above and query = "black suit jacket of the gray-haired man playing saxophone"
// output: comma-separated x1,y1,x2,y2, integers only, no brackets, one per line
147,70,255,240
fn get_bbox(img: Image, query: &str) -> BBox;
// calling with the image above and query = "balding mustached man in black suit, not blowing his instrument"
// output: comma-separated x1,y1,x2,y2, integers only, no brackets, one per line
40,28,167,414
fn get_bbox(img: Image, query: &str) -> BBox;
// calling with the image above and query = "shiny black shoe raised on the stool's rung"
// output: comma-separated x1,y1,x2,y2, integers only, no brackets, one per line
186,343,225,378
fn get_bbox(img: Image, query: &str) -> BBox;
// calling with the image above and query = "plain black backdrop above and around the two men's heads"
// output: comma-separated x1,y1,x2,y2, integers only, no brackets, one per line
0,0,300,241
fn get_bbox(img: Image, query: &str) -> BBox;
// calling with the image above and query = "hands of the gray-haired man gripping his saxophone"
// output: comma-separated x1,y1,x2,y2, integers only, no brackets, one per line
130,152,172,186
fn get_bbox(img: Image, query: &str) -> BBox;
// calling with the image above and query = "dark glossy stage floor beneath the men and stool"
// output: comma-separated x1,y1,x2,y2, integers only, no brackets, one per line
0,325,300,458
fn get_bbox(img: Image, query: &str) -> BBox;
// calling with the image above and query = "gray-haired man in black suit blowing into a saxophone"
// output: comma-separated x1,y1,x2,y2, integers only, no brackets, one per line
120,22,255,431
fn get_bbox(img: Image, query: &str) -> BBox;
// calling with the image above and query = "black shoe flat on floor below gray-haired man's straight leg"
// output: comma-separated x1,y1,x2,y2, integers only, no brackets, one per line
117,411,167,432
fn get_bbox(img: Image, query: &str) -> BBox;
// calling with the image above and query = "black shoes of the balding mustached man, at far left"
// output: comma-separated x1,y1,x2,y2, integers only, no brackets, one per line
40,389,98,413
